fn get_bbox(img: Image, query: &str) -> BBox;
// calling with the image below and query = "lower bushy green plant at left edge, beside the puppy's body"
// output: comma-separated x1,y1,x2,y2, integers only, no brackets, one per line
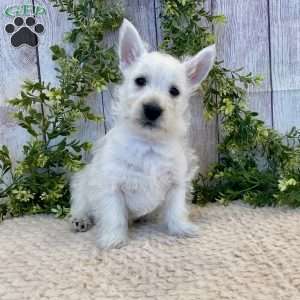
0,82,99,216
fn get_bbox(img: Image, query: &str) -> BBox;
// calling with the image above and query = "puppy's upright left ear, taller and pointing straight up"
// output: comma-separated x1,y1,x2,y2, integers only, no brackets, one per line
119,19,146,71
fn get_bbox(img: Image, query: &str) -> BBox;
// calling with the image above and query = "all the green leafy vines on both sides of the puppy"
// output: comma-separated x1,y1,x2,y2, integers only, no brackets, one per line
0,0,300,218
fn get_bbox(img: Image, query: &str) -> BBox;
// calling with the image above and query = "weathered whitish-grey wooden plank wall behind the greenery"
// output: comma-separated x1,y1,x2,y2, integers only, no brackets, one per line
0,0,300,170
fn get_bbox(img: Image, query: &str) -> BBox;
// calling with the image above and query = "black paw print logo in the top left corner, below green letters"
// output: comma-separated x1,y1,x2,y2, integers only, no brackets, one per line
5,17,45,48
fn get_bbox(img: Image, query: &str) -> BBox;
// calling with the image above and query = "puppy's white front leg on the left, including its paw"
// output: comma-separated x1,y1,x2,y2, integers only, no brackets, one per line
95,191,128,249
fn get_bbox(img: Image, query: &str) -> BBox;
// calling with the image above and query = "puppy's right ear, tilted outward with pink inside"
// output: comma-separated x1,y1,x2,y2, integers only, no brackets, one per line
183,45,216,90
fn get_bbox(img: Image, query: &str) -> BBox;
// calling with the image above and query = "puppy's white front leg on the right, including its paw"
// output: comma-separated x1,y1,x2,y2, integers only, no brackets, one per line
162,185,197,236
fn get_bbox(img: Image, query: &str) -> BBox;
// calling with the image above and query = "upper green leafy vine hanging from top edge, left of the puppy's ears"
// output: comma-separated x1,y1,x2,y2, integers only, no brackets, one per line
50,0,123,97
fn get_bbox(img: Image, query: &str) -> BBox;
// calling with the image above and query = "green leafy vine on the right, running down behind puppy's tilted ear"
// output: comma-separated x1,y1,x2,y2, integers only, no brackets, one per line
162,0,300,207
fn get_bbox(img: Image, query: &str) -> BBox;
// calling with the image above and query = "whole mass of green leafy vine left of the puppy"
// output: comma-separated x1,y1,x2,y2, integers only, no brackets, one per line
0,0,123,218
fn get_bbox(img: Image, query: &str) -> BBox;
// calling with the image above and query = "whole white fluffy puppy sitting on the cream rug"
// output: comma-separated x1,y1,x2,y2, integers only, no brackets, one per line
71,20,216,248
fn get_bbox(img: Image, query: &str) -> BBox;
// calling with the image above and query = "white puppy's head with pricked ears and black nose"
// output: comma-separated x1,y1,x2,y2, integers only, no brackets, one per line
117,19,216,137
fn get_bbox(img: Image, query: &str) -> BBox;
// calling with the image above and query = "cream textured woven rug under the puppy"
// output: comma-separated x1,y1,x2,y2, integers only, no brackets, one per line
0,203,300,300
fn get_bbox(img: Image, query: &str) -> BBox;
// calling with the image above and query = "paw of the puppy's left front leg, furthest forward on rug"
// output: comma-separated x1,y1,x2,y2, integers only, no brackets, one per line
97,231,128,249
